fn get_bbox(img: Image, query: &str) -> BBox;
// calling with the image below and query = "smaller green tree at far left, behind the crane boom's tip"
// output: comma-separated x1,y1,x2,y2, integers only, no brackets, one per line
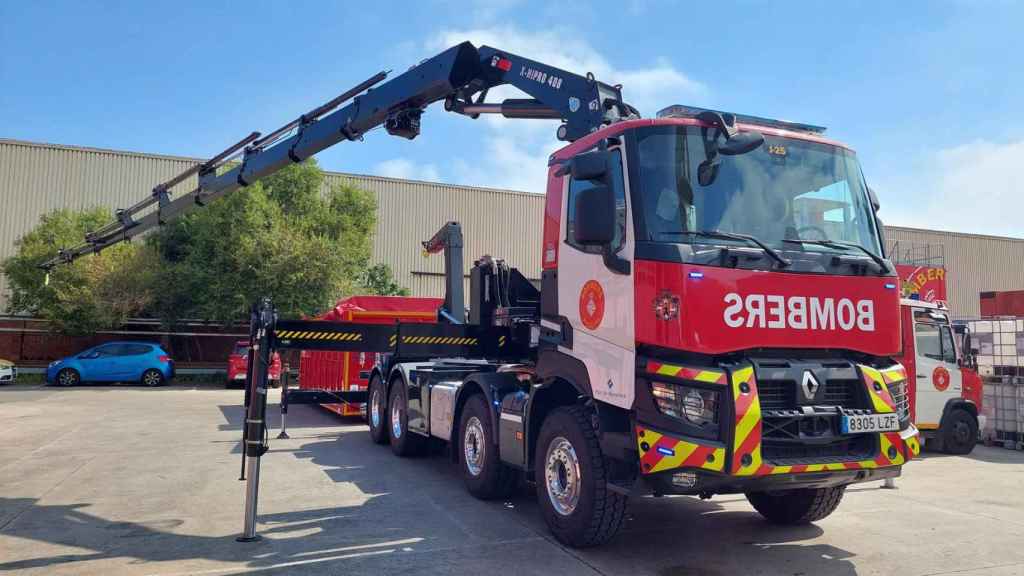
2,208,153,334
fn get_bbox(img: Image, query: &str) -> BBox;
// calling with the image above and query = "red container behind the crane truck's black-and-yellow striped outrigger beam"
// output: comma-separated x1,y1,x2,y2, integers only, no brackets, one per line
299,296,444,416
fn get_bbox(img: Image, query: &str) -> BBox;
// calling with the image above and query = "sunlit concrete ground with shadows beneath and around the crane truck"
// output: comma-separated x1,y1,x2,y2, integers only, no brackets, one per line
0,385,1024,576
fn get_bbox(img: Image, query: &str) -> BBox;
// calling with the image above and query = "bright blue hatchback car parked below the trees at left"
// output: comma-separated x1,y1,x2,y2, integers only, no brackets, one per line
46,342,174,386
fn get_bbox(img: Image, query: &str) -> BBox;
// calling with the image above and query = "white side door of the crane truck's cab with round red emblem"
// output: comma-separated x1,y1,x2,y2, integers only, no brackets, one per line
558,148,636,408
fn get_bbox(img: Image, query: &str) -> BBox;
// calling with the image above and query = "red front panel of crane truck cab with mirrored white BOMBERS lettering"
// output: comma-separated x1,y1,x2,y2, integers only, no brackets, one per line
635,260,900,356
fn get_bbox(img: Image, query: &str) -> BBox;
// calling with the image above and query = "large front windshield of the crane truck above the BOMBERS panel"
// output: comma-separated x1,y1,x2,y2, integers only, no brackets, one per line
638,126,880,253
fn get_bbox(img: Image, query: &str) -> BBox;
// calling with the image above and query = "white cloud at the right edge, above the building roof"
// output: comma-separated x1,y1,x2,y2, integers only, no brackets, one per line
880,140,1024,238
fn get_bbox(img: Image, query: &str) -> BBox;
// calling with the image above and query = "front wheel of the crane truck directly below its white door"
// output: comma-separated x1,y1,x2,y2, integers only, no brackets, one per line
534,406,627,547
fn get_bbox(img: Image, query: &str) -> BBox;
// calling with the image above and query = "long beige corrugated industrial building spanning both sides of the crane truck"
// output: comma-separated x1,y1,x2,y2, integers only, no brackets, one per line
0,139,1024,318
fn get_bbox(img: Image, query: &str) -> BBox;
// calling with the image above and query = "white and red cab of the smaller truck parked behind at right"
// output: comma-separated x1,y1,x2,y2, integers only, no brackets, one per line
897,298,985,454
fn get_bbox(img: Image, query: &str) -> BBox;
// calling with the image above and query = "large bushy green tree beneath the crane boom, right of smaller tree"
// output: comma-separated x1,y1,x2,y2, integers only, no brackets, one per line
151,160,385,323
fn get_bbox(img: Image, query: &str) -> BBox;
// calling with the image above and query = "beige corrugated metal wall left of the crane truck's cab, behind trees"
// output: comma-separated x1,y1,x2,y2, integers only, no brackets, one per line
0,139,544,310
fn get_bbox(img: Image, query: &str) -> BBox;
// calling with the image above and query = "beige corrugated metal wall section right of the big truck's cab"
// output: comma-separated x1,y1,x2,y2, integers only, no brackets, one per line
886,227,1024,318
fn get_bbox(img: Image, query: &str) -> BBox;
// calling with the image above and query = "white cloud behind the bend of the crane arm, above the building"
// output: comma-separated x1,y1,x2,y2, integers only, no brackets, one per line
426,26,708,193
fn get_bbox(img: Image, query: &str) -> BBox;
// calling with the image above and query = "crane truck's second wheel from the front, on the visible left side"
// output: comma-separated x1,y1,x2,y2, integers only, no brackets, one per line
456,394,516,500
